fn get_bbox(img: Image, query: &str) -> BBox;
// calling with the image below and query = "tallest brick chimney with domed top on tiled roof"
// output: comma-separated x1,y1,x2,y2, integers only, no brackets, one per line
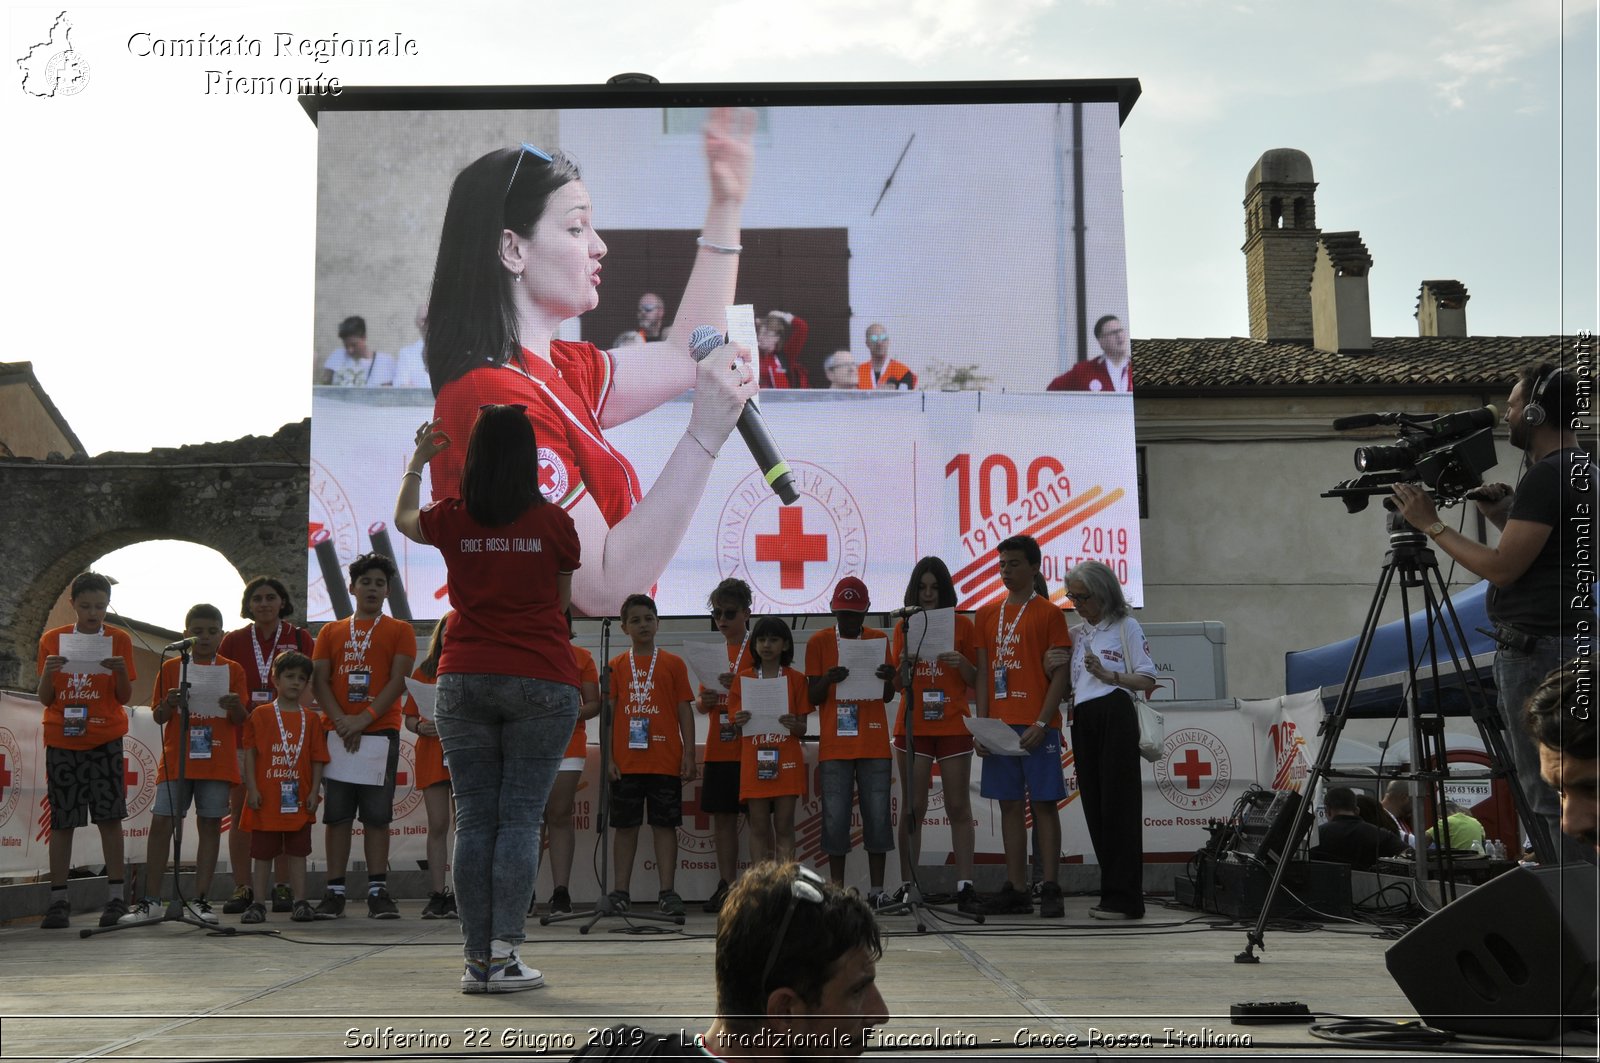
1240,147,1318,343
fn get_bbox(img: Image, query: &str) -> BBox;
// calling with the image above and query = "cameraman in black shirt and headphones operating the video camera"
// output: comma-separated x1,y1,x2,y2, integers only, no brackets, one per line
1394,362,1595,863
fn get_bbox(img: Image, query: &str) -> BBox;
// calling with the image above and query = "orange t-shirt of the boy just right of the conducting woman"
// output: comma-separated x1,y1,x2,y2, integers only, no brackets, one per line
611,650,694,776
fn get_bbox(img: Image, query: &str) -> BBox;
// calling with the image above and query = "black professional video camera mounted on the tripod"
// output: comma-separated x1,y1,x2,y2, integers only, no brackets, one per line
1322,407,1499,512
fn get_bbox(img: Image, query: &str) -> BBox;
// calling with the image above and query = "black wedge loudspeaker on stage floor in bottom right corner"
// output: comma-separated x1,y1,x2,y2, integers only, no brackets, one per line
1384,864,1597,1041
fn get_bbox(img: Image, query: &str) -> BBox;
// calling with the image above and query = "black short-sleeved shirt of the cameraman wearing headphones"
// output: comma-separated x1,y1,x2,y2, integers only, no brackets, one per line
1488,450,1595,639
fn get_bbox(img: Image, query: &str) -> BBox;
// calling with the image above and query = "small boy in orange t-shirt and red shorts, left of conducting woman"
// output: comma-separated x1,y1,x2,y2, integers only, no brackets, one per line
240,650,328,922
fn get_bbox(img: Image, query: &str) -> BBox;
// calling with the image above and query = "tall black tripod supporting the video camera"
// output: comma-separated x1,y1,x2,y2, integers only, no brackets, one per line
1234,515,1554,964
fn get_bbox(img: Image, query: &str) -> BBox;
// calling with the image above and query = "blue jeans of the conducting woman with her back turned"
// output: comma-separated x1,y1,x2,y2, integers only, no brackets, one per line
434,674,578,961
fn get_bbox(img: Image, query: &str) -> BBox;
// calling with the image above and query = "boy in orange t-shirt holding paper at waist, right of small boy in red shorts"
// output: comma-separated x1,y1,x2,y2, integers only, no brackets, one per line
312,554,416,919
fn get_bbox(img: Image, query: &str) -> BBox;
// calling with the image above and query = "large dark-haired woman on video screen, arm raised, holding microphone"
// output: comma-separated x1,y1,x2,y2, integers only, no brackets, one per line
427,109,755,615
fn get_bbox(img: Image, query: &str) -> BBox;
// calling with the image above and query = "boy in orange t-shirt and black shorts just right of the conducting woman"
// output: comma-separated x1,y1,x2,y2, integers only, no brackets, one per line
608,594,694,916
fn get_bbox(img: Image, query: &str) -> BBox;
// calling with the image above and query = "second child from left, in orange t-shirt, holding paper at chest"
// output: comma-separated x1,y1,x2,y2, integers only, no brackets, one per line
118,605,250,924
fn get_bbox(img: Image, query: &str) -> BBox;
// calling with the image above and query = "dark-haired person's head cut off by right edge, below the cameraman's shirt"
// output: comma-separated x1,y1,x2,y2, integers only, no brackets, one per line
1523,658,1600,850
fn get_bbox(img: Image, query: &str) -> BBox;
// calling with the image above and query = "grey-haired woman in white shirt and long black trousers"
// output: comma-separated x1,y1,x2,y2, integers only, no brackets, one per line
1046,560,1155,919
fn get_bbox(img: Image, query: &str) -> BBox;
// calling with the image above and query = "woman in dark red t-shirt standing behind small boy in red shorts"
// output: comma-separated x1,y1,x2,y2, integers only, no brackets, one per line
218,576,315,916
